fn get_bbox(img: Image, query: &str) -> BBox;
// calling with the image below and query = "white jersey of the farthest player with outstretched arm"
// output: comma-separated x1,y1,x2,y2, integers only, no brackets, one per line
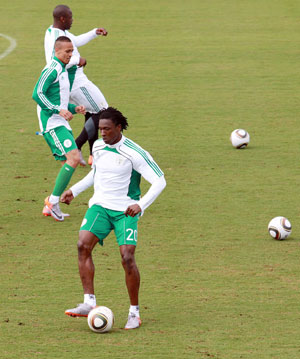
44,25,97,90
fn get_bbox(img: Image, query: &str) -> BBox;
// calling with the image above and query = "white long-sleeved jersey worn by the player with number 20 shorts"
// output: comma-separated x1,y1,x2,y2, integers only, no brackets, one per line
71,136,166,211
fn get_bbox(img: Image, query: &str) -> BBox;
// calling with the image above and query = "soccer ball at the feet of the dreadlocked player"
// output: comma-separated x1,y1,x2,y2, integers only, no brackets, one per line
87,306,114,333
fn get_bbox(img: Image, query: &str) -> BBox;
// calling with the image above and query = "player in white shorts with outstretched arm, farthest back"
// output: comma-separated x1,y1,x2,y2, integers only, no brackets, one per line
44,5,108,166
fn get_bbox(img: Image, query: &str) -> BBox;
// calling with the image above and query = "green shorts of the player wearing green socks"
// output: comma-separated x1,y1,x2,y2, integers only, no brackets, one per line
44,126,77,161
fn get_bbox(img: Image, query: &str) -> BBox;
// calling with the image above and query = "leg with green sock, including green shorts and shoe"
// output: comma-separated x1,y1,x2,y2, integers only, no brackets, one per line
44,126,79,221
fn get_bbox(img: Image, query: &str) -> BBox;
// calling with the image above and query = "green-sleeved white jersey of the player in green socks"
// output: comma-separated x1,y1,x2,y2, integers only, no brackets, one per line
32,57,76,132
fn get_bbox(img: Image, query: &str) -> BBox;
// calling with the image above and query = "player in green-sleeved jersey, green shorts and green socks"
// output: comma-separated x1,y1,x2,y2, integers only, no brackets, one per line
32,36,85,221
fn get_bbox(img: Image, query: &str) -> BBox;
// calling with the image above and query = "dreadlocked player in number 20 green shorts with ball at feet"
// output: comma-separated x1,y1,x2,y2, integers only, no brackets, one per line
61,107,166,329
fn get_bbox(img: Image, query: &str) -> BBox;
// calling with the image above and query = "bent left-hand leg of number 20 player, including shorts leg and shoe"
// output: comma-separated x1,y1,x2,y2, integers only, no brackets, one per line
65,205,112,317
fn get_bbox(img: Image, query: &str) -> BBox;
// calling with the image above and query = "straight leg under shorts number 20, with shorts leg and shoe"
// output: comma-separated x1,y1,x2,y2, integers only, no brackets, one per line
114,213,141,329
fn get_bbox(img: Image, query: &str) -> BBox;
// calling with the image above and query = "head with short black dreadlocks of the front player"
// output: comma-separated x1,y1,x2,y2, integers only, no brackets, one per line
99,107,128,145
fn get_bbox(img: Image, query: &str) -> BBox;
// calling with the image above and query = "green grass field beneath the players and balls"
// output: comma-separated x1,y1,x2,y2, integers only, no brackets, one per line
0,0,300,359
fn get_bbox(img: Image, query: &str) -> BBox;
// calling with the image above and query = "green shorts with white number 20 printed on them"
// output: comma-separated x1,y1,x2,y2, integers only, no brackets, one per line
80,204,139,246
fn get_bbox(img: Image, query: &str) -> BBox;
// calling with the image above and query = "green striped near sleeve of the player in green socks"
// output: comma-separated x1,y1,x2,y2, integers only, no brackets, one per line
32,68,61,113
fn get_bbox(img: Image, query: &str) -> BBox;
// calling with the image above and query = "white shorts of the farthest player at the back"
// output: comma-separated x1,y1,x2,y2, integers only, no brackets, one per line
70,80,108,113
